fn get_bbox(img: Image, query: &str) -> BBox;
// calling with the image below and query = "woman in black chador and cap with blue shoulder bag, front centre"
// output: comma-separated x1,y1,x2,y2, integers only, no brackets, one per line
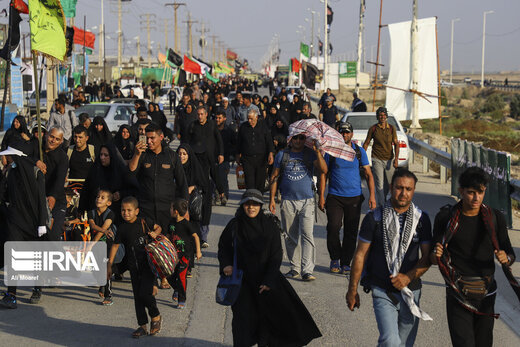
218,189,321,346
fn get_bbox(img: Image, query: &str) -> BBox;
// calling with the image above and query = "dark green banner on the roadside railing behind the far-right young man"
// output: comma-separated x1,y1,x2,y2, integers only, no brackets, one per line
451,139,513,227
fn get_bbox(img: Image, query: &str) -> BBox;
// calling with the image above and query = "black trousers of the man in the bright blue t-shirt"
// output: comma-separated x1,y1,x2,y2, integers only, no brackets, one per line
325,194,362,266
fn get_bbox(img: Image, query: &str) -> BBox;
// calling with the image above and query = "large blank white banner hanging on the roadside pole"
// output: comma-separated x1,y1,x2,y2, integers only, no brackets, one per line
386,17,439,121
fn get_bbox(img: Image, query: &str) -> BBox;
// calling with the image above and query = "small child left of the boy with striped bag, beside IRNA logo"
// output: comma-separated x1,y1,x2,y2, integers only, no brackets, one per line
88,189,115,306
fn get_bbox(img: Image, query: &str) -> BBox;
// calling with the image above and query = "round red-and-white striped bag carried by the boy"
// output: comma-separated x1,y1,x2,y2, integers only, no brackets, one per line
141,220,179,278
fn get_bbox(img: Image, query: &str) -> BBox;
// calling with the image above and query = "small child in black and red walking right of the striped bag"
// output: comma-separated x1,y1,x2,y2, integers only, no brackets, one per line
168,199,202,309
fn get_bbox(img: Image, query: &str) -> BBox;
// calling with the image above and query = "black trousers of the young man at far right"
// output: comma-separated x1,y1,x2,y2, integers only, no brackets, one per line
446,288,496,347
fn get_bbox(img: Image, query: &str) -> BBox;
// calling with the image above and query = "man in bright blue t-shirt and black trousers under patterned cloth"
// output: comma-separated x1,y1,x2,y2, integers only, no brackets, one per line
318,122,376,275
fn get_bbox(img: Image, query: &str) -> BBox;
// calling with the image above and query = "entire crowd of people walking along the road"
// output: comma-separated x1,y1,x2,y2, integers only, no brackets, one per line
0,78,515,346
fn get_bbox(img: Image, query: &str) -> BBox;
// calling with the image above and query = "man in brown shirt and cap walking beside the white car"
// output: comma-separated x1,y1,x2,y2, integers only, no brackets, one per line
363,107,399,206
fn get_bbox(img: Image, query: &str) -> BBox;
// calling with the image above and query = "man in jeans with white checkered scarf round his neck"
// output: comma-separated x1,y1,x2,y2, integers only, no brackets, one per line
346,169,432,346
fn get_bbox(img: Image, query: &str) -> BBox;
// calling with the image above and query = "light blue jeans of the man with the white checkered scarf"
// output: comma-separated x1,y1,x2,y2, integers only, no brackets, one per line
372,286,421,347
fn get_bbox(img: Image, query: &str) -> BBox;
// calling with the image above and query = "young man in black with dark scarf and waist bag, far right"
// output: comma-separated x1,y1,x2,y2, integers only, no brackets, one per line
430,167,520,346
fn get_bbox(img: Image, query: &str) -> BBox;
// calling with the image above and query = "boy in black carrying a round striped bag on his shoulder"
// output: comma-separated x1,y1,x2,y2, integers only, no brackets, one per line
107,196,162,338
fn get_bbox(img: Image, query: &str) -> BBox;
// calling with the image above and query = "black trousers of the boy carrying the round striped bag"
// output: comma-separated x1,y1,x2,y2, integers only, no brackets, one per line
130,264,160,325
